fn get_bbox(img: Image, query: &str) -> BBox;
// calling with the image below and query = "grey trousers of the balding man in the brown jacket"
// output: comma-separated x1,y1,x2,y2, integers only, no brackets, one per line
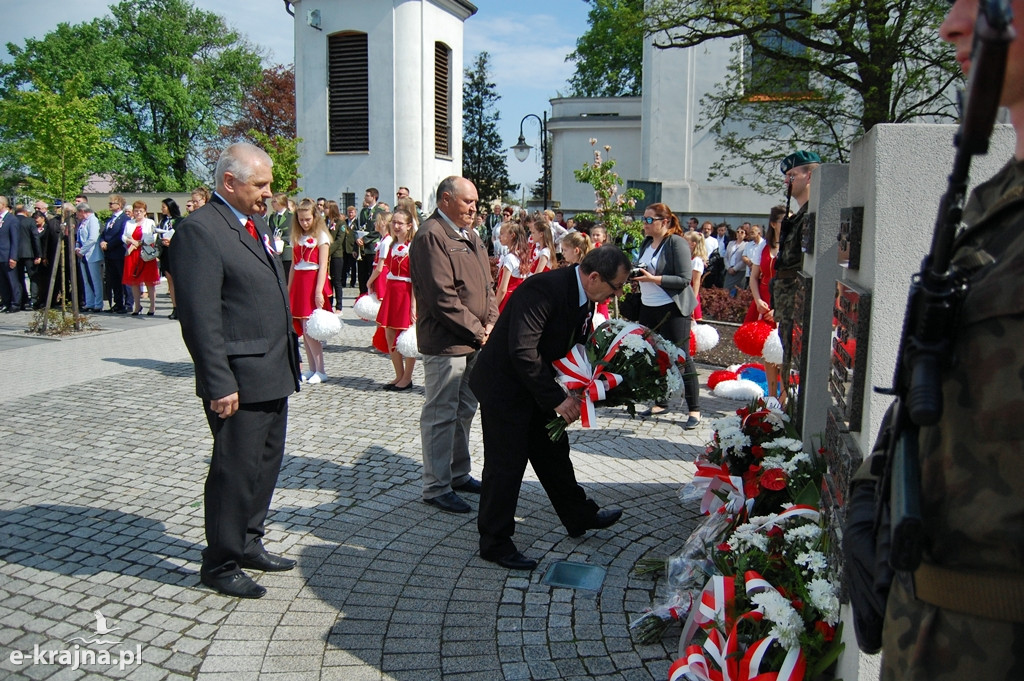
420,352,477,499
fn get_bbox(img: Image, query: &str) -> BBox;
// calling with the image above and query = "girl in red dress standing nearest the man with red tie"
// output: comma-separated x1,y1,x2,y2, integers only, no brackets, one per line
288,199,332,384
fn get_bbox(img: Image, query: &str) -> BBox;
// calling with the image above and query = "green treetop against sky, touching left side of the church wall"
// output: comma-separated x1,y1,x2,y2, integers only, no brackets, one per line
565,0,644,97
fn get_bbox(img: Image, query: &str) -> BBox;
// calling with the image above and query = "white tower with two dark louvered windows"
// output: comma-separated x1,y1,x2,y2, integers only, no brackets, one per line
291,0,476,209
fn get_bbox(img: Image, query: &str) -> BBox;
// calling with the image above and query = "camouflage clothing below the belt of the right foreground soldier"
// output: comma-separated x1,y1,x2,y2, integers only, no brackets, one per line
880,573,1024,681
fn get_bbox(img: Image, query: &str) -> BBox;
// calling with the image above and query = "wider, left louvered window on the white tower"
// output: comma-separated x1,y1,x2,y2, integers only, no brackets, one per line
328,33,370,152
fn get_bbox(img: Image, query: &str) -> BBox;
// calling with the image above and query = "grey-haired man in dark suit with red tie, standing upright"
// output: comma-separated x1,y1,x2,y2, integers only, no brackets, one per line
171,142,299,598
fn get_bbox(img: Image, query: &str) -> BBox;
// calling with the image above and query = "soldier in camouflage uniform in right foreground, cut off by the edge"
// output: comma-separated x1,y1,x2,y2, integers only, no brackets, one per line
882,0,1024,681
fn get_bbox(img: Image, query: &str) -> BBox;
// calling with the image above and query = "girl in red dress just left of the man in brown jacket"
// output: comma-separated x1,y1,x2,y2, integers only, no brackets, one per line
375,208,416,390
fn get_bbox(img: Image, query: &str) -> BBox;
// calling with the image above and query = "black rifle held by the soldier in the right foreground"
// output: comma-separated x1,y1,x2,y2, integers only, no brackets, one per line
874,0,1014,570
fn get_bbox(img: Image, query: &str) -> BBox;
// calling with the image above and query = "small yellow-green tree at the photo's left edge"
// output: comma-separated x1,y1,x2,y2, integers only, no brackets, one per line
0,76,108,198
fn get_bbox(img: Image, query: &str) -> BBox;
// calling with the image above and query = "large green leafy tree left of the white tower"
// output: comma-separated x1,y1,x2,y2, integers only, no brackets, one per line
0,0,261,191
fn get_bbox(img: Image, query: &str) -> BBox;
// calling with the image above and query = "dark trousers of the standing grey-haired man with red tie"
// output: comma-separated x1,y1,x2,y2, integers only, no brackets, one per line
203,397,288,574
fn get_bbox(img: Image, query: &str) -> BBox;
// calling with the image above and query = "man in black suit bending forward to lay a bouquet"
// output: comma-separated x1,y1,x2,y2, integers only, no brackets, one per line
469,248,630,569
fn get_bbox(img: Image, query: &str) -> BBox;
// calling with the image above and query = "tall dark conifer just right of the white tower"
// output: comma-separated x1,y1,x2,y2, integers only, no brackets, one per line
462,52,517,201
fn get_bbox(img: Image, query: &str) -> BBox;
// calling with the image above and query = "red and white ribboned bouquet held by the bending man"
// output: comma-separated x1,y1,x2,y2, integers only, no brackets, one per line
548,318,686,440
